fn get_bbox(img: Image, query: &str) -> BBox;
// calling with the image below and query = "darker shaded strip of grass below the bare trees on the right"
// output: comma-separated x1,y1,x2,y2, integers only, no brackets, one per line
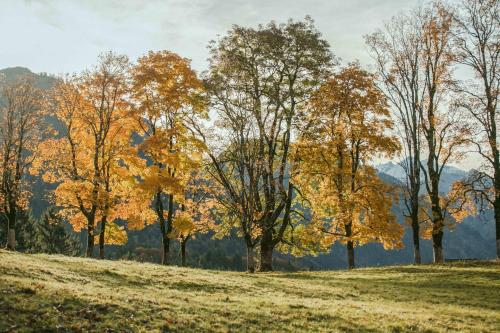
270,263,500,311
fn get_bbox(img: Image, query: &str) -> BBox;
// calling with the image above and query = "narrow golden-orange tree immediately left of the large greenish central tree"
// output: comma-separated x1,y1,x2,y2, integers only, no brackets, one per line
132,51,207,264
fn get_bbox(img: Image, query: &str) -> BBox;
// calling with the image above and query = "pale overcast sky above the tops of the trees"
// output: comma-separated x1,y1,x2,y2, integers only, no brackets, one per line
0,0,422,74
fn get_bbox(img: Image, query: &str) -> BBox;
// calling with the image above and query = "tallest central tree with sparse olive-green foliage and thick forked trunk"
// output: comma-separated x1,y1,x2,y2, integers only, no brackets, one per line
206,19,332,271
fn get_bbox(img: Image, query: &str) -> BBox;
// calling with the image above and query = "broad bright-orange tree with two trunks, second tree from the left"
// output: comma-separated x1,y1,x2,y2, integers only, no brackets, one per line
33,53,148,257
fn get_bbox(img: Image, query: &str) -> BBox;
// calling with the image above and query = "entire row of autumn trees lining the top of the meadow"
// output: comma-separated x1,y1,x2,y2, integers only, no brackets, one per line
0,0,500,271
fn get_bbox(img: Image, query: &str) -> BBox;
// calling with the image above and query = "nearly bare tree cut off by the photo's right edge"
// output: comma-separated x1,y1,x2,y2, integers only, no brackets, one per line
454,0,500,258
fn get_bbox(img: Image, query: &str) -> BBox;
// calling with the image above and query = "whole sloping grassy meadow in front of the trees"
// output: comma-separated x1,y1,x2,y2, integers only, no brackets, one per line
0,250,500,332
